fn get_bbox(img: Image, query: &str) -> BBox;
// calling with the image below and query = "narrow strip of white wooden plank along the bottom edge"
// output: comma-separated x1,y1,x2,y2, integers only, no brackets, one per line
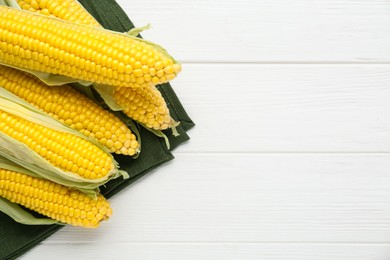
21,243,390,260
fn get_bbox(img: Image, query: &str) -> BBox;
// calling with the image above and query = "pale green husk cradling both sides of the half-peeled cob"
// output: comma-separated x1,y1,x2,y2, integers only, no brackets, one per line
0,88,128,194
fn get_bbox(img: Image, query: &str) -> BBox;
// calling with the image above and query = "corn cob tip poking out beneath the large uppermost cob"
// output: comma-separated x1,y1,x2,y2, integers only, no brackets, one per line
114,85,173,130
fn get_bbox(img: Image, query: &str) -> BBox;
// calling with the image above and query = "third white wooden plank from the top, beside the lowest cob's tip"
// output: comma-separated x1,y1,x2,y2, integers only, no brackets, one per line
31,153,390,244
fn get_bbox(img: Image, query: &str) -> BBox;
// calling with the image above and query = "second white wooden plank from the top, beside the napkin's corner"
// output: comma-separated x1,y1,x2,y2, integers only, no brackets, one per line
172,64,390,152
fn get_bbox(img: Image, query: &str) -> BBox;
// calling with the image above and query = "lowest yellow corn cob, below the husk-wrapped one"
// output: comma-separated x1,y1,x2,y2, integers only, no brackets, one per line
0,169,112,228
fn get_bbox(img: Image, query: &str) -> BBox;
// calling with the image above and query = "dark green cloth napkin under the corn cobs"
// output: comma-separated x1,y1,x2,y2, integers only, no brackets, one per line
0,0,194,259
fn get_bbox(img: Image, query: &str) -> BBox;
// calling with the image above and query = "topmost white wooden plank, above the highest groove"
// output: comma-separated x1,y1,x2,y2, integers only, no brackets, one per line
118,0,390,62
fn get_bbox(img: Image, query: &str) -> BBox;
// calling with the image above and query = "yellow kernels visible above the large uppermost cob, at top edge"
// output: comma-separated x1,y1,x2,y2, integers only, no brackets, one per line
17,0,99,26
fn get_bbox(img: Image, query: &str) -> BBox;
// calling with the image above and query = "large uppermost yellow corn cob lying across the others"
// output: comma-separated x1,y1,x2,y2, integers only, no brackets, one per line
0,6,181,87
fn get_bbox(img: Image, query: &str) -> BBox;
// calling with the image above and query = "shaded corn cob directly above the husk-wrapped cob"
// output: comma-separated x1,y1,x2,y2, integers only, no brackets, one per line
0,65,139,155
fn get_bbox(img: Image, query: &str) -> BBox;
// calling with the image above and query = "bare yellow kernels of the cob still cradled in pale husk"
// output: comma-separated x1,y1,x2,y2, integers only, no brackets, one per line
0,110,114,179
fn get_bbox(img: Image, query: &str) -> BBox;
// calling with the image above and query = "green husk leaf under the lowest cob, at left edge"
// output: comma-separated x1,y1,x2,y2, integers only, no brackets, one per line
0,197,61,225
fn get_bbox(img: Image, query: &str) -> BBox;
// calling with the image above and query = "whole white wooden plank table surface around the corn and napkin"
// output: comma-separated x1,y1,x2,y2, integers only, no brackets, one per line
22,0,390,260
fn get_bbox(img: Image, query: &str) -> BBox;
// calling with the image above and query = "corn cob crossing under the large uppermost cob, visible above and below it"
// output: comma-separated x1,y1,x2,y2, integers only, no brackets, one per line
15,0,174,130
